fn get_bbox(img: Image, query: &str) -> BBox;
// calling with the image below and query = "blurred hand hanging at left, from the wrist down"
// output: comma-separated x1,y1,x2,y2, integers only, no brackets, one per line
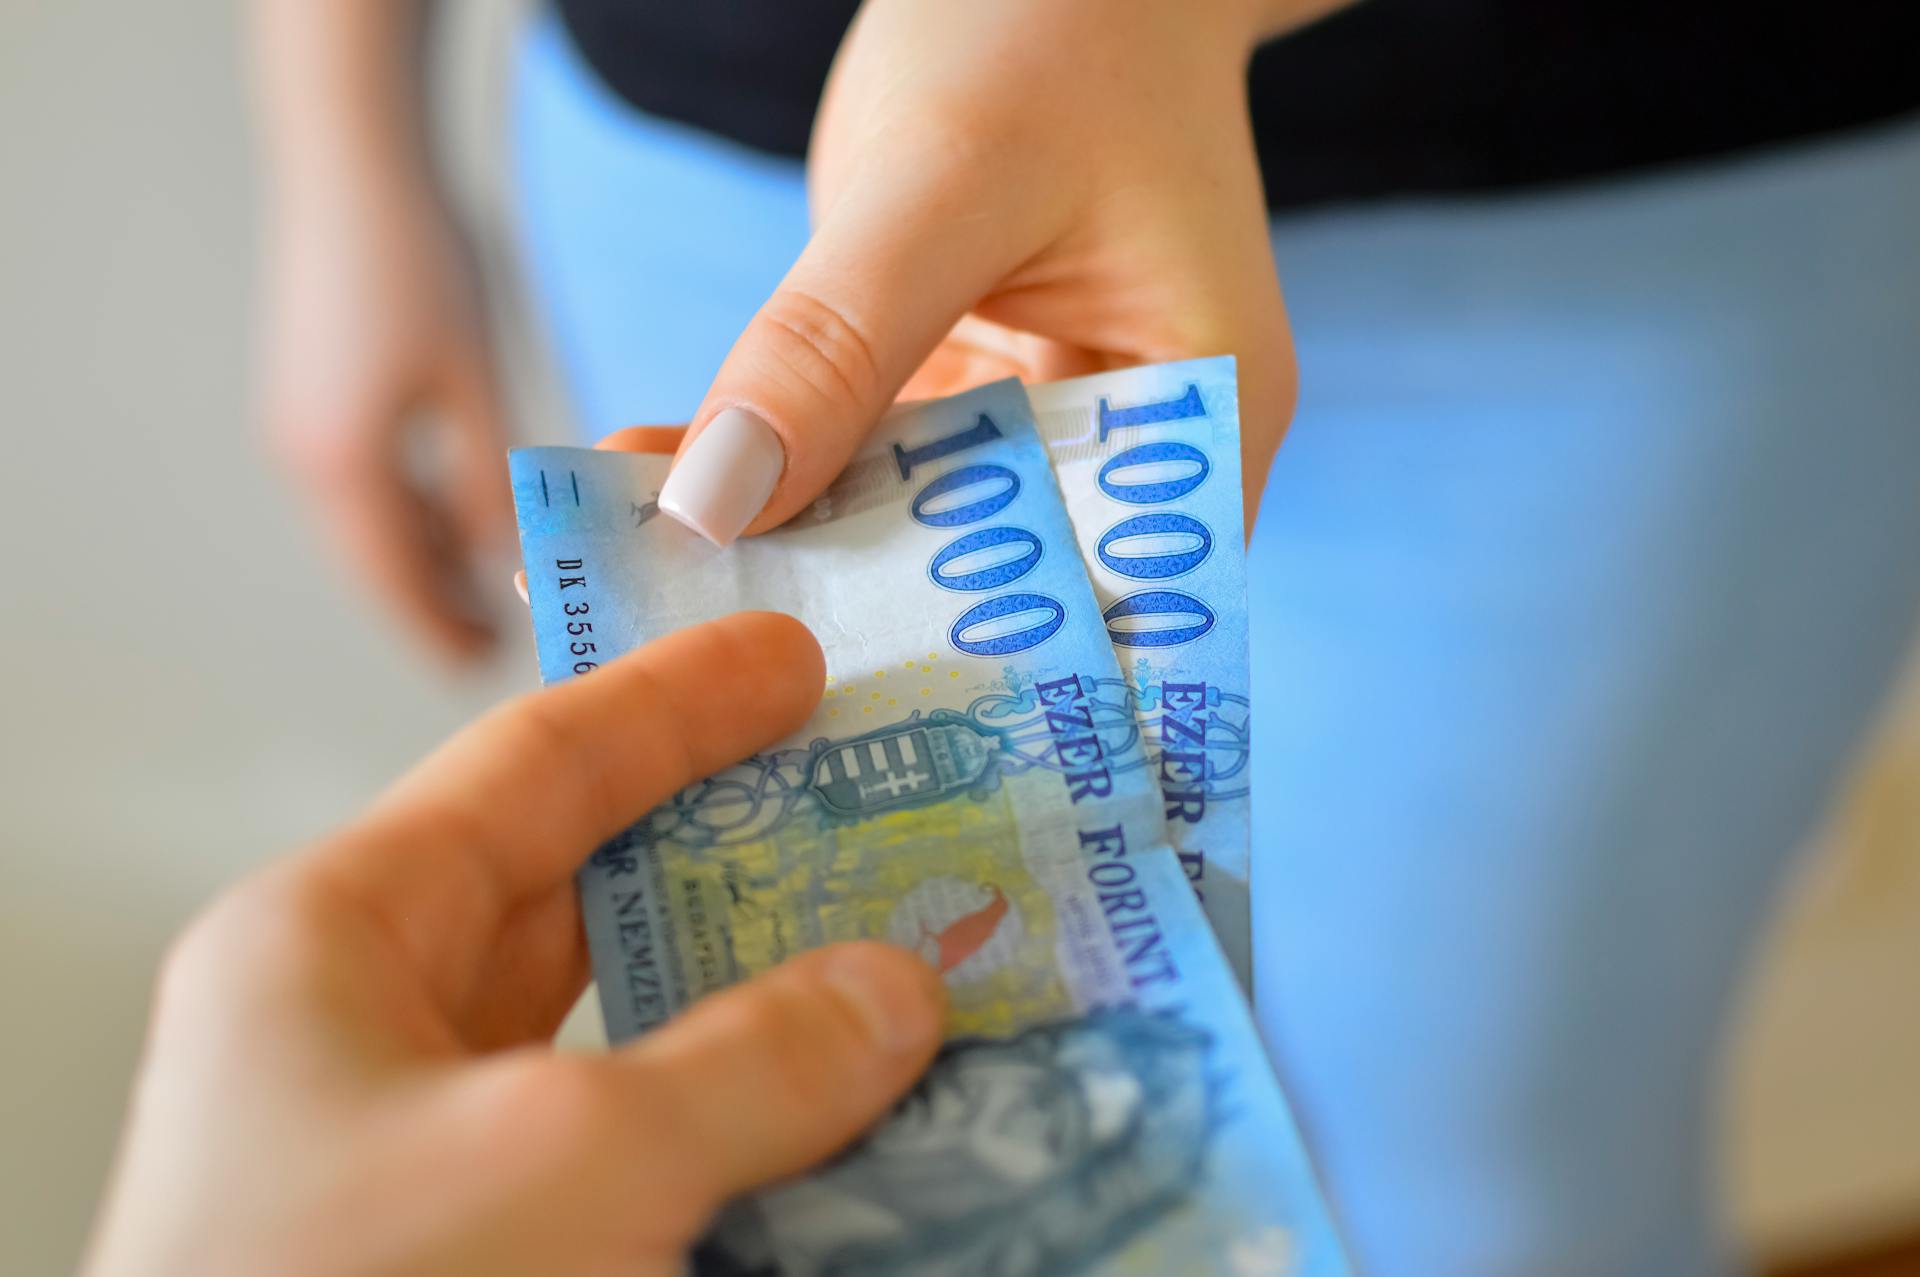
265,184,513,661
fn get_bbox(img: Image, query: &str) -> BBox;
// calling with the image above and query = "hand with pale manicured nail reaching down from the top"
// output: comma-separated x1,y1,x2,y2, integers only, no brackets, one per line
645,0,1332,543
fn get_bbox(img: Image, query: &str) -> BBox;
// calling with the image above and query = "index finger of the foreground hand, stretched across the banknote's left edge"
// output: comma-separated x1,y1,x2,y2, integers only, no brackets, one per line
319,613,826,989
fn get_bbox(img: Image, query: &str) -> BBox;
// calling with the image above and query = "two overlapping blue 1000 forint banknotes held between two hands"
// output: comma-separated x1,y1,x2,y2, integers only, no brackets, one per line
513,359,1350,1277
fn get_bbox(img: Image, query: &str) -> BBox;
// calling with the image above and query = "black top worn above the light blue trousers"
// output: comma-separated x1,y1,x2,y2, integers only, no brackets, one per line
555,0,1920,207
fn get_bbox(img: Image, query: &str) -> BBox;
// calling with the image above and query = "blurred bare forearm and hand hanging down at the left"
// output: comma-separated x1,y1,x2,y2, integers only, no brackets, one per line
255,0,513,661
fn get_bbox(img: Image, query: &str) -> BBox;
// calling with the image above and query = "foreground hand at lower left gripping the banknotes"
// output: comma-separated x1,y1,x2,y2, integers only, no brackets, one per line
86,613,941,1277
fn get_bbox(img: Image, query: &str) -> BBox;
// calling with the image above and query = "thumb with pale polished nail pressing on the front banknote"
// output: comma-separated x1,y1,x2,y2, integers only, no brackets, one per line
660,175,1027,545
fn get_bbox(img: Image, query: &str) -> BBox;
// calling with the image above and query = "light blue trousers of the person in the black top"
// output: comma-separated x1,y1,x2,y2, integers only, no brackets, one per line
515,14,1920,1277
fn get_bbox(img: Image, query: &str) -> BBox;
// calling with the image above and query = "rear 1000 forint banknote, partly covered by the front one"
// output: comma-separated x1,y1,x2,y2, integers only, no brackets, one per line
1027,355,1252,989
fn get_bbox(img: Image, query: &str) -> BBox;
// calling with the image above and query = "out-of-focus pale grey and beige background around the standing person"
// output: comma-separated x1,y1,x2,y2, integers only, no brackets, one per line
0,0,1920,1273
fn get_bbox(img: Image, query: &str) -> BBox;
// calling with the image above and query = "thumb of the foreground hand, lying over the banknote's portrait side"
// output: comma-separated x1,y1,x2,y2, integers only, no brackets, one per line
612,941,947,1239
